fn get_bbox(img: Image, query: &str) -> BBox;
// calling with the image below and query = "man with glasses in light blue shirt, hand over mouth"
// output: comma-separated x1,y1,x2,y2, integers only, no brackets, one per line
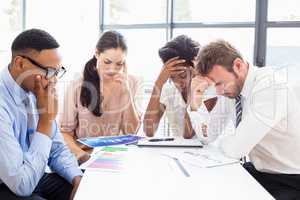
0,29,82,200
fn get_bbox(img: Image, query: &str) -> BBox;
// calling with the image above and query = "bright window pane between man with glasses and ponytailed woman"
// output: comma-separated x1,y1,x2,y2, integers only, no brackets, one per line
26,0,99,81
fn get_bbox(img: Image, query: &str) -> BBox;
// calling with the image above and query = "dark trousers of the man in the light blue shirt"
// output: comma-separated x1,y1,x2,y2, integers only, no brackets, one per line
0,173,72,200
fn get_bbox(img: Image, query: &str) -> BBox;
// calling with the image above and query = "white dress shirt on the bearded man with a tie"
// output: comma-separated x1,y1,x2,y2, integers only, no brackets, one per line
189,66,300,174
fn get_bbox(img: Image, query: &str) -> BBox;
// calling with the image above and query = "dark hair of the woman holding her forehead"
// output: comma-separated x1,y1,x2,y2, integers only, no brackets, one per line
158,35,200,67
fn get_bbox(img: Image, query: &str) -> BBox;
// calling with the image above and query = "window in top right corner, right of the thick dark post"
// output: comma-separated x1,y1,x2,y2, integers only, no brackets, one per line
266,0,300,67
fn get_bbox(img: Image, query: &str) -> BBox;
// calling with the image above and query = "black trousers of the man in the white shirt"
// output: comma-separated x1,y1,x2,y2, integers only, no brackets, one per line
243,162,300,200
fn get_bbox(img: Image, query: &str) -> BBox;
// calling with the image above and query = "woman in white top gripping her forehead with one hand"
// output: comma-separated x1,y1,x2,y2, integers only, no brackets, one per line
143,35,215,138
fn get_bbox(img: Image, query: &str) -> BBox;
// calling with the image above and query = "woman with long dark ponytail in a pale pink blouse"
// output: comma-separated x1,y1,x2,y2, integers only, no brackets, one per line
60,31,140,162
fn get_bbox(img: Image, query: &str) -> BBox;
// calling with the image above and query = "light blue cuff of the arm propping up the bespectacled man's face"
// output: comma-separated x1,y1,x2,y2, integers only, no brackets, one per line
30,132,52,159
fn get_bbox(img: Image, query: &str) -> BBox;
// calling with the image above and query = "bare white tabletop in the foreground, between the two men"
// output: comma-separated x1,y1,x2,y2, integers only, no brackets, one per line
75,145,273,200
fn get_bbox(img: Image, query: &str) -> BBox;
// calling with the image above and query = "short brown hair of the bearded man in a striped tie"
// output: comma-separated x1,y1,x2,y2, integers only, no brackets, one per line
196,40,243,76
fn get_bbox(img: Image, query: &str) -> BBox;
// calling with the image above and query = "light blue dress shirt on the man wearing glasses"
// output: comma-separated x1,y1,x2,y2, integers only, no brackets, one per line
0,67,82,196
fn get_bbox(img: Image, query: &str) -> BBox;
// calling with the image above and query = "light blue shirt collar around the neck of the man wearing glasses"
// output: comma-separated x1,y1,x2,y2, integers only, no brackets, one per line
0,65,29,105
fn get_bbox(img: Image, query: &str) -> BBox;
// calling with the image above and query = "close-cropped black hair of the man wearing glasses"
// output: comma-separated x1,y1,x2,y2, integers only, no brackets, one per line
11,29,59,56
